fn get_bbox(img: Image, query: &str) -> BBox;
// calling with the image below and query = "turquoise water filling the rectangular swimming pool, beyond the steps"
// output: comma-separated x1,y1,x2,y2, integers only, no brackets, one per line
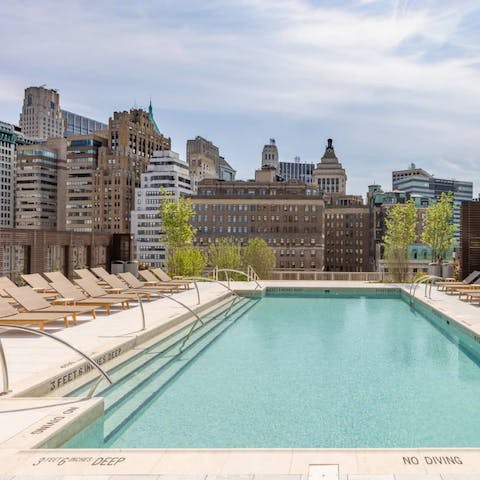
67,293,480,448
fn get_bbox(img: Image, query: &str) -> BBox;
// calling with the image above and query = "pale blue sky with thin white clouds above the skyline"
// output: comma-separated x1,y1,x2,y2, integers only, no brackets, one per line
0,0,480,195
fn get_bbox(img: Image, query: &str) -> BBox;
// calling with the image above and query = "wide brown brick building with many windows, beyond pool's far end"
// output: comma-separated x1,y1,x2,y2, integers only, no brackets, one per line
192,176,324,270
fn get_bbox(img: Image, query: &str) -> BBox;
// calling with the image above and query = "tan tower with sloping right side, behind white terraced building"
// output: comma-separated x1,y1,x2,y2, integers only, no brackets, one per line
187,136,236,191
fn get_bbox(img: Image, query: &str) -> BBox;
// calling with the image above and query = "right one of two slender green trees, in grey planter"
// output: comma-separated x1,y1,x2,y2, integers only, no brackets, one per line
422,192,455,263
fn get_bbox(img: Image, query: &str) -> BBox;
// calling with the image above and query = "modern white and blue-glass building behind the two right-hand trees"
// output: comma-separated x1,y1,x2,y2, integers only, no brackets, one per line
392,164,473,246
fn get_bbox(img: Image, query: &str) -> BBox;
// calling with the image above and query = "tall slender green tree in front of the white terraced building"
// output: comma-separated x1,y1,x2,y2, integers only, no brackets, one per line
159,189,205,276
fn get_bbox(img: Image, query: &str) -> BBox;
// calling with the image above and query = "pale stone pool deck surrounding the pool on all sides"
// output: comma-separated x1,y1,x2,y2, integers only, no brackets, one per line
0,281,480,480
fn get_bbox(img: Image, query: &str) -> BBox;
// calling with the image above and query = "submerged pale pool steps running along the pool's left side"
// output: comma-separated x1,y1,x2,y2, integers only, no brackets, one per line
98,299,258,442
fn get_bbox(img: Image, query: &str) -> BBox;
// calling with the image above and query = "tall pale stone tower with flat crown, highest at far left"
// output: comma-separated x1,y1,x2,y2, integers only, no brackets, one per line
20,86,64,140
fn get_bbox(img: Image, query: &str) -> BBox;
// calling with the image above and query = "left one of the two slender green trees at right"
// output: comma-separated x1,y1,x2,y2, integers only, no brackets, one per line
383,200,417,282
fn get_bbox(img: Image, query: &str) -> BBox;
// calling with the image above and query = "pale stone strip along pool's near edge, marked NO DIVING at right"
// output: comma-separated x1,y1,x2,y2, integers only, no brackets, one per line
0,449,480,480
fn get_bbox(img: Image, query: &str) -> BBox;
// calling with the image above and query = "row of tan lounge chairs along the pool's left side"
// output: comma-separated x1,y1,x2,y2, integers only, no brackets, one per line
0,268,190,330
